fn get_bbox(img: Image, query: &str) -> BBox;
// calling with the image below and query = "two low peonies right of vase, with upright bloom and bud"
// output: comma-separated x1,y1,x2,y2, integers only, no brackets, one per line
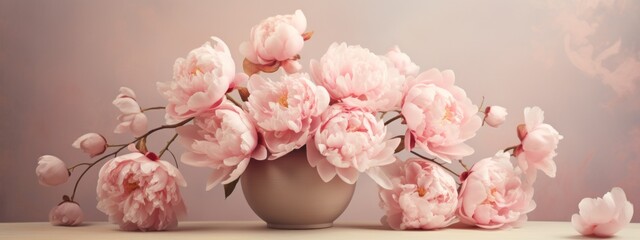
380,106,562,229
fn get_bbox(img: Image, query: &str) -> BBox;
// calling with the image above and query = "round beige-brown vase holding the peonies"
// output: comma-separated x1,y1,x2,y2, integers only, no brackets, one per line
240,147,355,229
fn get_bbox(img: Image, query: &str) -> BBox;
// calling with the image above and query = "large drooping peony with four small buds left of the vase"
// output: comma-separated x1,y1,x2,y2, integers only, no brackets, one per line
36,87,186,231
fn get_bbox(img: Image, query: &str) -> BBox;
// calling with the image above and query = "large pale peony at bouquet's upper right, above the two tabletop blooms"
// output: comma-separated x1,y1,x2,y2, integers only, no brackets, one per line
402,69,482,163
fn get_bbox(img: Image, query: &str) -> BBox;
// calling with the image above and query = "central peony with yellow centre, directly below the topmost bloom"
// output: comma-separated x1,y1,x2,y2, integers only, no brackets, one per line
247,73,329,159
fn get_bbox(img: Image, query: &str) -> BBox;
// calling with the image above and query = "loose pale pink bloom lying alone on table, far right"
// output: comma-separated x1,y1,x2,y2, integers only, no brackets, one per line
571,187,633,237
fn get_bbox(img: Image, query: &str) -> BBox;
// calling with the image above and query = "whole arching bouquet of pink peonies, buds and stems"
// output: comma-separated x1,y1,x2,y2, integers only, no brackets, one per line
36,10,632,235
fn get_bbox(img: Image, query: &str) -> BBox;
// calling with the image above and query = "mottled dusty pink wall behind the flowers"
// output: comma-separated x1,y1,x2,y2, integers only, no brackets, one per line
0,0,640,222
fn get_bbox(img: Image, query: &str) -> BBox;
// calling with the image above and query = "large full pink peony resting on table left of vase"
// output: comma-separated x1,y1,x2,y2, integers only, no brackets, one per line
97,152,187,231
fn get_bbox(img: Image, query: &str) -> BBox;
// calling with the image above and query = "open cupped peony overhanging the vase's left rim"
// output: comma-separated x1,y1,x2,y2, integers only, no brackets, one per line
176,102,267,190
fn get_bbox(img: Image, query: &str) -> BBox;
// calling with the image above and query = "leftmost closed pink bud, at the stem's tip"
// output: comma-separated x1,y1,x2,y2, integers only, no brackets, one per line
36,155,70,187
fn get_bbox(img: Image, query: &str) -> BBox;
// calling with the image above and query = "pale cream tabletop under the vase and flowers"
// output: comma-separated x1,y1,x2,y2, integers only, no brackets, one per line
0,221,640,240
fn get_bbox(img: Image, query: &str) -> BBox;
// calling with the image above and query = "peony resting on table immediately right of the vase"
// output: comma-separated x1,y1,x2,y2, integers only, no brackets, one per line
380,158,458,230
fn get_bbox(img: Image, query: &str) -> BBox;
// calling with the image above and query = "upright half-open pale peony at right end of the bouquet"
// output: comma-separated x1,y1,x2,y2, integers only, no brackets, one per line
515,107,563,182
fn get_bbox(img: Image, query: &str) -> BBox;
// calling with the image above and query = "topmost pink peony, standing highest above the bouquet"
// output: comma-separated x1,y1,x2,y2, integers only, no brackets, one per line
240,10,307,73
